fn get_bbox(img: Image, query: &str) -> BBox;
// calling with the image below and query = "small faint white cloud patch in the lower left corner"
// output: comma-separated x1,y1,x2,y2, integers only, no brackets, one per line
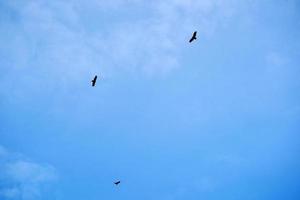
0,146,58,200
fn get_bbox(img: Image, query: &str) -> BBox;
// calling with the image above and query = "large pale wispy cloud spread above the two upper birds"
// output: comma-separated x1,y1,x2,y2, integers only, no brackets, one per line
1,0,243,81
